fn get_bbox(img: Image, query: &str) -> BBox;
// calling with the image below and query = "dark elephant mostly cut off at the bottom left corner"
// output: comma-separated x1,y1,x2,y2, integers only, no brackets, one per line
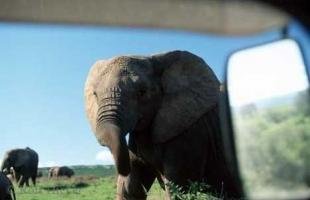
0,172,16,200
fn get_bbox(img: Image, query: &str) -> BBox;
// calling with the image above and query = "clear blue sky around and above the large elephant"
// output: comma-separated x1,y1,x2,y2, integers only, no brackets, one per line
0,23,310,166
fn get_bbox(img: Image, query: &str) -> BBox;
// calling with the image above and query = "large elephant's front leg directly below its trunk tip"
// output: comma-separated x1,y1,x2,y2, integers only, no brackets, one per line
116,152,156,200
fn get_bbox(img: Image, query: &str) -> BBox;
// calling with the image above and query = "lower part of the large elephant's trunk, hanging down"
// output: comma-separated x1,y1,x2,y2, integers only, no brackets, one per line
96,122,130,176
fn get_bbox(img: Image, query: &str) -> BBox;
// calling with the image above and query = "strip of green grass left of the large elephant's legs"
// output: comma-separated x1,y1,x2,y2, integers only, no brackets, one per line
15,176,116,200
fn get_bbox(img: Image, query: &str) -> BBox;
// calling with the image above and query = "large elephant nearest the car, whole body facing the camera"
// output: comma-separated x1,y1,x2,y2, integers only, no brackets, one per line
84,51,241,199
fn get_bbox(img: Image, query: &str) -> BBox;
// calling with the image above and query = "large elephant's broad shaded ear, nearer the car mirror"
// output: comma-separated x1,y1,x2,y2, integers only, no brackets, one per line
151,51,220,143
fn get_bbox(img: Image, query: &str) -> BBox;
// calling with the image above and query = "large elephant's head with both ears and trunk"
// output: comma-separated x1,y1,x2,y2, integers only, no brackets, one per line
85,51,219,176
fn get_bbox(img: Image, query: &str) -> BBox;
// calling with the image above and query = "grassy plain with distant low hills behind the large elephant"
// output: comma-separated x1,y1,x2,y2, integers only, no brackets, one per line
15,166,164,200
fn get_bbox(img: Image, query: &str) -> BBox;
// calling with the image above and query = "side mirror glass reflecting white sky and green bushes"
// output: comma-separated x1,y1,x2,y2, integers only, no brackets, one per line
227,39,310,199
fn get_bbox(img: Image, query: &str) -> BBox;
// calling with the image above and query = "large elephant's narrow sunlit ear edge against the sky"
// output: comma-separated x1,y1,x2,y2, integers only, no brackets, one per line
84,60,107,133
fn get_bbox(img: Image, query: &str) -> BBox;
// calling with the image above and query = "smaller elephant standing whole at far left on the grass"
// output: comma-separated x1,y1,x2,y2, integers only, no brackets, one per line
1,147,39,187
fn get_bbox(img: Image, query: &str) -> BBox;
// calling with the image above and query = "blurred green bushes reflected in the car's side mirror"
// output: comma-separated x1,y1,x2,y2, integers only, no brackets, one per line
234,91,310,192
